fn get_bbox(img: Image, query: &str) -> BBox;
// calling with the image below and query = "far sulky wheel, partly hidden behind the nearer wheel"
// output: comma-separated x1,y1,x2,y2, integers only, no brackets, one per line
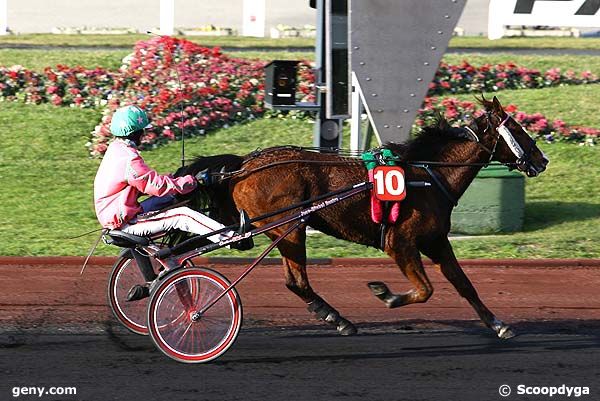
108,251,159,335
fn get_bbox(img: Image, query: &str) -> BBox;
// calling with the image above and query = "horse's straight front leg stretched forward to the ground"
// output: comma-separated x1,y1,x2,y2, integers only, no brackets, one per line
421,236,515,339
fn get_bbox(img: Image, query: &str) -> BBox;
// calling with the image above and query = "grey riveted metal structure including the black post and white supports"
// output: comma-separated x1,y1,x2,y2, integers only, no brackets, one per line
264,0,466,150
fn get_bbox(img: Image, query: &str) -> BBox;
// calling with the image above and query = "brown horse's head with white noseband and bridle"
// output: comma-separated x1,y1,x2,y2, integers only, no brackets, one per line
477,96,549,177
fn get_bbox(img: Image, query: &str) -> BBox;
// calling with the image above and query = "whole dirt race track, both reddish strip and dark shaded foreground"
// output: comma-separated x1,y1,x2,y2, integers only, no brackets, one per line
0,257,600,401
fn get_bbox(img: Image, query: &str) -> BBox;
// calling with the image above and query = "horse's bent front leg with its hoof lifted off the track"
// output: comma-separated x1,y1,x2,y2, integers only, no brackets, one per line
368,239,433,308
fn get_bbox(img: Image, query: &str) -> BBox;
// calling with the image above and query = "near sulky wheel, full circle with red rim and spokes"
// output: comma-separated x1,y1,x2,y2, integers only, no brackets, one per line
148,267,242,363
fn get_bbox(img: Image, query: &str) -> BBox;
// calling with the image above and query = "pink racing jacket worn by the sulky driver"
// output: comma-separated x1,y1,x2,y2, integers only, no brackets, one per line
94,139,196,229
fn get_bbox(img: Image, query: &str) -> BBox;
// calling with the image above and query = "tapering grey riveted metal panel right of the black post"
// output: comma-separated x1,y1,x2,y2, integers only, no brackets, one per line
349,0,466,148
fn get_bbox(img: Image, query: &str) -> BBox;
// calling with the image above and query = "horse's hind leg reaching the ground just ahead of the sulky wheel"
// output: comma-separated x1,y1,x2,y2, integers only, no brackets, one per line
269,229,356,336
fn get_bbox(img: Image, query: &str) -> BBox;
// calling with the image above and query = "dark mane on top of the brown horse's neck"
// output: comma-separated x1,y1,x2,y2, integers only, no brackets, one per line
383,115,467,160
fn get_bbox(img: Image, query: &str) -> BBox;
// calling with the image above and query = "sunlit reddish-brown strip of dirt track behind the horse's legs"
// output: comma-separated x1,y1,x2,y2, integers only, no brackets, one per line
0,258,600,328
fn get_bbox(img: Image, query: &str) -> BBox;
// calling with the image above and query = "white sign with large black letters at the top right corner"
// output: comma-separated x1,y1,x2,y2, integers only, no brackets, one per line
488,0,600,39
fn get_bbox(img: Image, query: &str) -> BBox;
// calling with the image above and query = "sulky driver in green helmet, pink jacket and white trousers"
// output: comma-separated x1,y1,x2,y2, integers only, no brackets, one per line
94,105,252,300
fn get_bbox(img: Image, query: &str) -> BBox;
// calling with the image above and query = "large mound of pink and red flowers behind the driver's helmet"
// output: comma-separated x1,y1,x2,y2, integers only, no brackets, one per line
90,37,264,155
